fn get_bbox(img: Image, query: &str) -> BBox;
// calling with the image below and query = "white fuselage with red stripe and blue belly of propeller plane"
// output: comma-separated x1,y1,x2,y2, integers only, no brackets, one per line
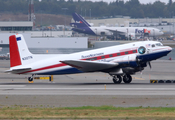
10,41,172,75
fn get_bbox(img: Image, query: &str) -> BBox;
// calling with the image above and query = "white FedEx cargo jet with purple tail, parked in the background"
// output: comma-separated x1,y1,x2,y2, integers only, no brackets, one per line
70,13,164,38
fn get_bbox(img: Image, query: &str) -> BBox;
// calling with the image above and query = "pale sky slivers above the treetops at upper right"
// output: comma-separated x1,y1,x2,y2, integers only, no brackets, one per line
90,0,175,4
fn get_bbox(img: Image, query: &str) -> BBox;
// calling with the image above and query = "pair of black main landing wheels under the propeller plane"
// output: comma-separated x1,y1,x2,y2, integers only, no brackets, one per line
112,74,132,84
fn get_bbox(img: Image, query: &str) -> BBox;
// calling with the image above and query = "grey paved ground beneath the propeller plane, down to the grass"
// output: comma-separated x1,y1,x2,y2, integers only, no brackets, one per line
0,60,175,107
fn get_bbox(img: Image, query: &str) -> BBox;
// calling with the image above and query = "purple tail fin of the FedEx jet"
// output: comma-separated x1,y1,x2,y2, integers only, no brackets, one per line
70,13,91,28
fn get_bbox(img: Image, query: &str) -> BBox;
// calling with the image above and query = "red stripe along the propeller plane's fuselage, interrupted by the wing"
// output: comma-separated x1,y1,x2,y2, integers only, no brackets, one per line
19,49,138,74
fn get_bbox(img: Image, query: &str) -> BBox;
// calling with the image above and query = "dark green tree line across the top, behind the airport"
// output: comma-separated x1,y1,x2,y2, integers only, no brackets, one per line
0,0,175,18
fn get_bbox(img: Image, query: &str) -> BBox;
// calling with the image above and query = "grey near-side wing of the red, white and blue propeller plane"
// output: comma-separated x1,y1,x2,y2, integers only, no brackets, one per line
60,60,119,72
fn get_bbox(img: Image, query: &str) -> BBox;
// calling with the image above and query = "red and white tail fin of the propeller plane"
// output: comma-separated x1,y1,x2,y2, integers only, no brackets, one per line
9,34,33,67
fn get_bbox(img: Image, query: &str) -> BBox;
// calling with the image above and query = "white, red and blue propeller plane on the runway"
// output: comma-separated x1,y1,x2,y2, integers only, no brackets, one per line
6,34,172,84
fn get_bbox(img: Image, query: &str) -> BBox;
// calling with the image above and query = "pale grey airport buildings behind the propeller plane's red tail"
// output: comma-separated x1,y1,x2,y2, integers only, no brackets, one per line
0,21,88,54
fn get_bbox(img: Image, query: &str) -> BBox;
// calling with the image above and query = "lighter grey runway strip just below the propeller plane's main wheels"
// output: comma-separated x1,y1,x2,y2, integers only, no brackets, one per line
0,81,175,95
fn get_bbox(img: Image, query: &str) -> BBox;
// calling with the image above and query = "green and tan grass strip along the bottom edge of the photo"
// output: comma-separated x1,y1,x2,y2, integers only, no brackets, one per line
0,106,175,120
